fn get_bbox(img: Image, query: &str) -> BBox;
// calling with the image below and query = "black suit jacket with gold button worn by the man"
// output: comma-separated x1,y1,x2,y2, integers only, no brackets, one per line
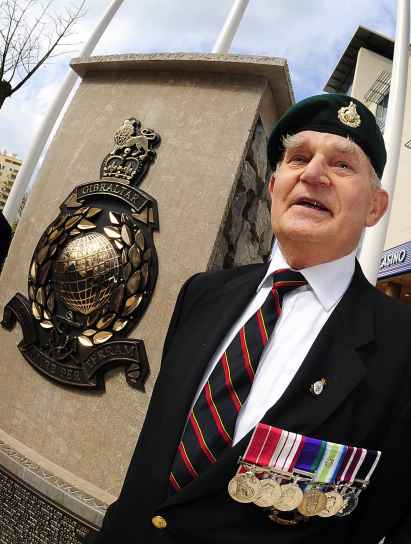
88,264,411,544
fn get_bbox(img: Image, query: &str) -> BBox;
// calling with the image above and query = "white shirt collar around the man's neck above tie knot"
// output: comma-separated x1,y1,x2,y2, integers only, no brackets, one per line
257,242,356,311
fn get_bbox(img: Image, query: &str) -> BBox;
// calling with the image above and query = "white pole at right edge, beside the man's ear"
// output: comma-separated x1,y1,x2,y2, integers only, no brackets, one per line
359,0,410,285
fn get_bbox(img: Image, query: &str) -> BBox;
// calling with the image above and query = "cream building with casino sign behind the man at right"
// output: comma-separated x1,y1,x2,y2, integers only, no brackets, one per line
324,27,411,303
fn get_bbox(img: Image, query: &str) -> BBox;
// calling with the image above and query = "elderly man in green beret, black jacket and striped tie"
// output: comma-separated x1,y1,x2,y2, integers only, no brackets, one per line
88,95,411,544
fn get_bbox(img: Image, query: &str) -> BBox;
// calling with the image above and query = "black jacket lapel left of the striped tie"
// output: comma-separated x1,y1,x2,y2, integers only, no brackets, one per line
152,264,267,502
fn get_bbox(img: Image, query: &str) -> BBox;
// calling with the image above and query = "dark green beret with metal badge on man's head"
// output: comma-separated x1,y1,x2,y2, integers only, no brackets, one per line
267,94,387,178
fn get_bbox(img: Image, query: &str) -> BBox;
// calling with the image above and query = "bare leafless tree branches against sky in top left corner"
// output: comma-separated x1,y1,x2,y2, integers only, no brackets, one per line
0,0,85,108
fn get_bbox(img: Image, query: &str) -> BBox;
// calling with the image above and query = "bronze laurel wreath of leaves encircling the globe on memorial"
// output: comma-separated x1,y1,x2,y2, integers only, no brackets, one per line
28,207,152,348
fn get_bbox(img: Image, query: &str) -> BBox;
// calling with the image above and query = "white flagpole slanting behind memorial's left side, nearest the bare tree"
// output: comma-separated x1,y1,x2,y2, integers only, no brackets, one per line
3,0,124,224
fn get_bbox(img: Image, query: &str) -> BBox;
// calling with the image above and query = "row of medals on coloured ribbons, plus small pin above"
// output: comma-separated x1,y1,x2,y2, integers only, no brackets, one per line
228,420,381,525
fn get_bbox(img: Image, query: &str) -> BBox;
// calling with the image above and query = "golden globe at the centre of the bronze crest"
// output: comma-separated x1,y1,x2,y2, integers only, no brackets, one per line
53,232,120,315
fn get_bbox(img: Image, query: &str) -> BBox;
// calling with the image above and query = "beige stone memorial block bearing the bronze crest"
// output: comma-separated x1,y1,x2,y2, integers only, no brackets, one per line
0,54,293,544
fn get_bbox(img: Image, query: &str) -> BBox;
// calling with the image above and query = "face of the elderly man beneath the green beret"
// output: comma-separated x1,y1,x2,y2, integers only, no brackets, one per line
269,131,388,264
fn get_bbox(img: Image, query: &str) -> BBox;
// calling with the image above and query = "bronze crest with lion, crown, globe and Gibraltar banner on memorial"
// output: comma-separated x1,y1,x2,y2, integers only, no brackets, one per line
2,118,160,391
